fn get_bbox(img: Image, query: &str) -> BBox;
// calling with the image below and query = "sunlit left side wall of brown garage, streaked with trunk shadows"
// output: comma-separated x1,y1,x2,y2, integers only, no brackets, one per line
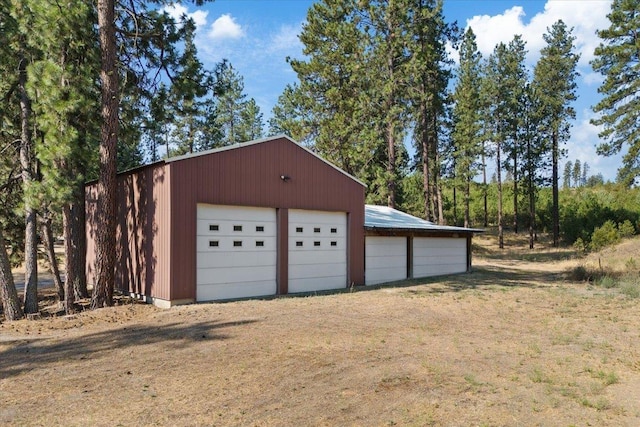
86,164,171,300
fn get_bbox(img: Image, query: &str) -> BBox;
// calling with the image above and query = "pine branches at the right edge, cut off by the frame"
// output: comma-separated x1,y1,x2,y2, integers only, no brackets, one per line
591,0,640,185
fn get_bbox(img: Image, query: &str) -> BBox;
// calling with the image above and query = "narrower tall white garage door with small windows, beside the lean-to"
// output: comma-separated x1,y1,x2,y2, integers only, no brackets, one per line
289,209,347,293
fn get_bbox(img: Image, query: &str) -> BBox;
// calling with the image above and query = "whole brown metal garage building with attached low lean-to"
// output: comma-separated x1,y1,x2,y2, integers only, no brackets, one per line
86,136,472,307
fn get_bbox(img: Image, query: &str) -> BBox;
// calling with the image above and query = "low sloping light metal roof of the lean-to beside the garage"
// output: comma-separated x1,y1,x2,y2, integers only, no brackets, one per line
364,205,484,233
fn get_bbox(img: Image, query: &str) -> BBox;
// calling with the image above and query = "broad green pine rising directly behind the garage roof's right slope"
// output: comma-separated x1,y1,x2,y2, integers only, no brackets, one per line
284,0,386,181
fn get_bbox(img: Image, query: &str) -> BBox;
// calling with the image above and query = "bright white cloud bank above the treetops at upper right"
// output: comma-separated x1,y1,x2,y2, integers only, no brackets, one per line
467,0,611,67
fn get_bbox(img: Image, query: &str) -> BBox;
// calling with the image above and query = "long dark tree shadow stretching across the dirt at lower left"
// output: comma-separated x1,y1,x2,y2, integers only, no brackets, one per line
0,320,256,378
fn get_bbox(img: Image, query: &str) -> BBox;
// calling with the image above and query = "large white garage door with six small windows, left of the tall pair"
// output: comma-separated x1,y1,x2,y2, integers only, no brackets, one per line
196,204,277,301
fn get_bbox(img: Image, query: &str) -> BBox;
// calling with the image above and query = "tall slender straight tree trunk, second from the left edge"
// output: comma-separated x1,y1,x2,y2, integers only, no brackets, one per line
18,52,38,313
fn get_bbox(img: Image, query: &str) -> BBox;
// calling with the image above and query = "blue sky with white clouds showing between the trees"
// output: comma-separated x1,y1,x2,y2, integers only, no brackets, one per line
168,0,620,180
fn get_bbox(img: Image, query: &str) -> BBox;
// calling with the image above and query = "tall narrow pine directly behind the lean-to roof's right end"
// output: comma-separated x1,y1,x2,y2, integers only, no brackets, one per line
452,28,482,227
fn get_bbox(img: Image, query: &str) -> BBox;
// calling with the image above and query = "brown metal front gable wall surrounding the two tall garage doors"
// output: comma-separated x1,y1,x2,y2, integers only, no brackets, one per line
167,138,364,299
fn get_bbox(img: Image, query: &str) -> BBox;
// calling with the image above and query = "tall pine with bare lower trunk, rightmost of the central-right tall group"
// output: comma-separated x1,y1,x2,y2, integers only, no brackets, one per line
533,20,580,247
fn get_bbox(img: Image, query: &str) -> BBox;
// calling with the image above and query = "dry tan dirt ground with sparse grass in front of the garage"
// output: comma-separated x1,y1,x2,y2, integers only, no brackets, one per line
0,236,640,426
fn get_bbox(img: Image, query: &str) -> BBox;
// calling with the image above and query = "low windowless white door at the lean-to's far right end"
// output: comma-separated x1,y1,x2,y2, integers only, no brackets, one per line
413,237,467,277
